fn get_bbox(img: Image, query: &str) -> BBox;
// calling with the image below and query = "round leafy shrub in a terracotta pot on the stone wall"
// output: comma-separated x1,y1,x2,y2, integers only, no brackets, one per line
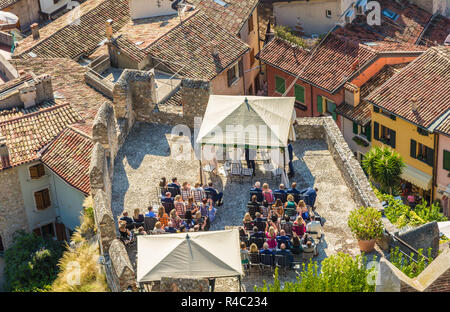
347,207,383,252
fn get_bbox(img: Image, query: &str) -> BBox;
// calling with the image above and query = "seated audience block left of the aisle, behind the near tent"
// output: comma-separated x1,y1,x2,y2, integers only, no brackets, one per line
119,178,223,244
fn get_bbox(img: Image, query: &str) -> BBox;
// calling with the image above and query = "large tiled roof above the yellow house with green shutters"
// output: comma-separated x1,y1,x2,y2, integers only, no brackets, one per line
366,46,450,128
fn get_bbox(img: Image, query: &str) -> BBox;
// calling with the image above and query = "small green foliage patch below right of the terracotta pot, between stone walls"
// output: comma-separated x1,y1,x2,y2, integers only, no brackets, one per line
389,247,432,278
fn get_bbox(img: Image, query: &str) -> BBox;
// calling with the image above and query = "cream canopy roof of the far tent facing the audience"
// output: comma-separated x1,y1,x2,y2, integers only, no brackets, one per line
196,95,295,147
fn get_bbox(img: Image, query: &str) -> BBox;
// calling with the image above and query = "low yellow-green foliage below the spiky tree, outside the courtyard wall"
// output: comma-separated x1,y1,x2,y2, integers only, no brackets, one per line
375,191,447,229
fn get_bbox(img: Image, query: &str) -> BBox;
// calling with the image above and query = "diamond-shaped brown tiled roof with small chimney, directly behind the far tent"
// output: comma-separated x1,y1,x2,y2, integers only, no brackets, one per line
144,11,249,81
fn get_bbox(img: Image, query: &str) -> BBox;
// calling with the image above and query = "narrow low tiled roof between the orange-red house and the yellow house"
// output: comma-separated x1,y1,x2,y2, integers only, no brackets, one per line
336,64,407,126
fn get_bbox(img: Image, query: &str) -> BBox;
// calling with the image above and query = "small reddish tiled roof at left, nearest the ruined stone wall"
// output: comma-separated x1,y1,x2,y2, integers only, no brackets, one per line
41,128,94,194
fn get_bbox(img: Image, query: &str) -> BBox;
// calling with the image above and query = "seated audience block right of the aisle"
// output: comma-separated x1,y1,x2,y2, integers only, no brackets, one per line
239,182,323,266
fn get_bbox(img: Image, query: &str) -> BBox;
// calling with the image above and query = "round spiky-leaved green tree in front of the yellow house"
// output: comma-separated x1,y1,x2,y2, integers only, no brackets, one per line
362,146,406,194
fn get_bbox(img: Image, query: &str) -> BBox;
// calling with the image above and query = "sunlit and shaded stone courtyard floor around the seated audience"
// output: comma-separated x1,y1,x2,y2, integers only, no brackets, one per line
112,123,366,291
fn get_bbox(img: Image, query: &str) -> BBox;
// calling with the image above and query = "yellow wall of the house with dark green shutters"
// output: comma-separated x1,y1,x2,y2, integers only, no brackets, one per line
372,106,436,176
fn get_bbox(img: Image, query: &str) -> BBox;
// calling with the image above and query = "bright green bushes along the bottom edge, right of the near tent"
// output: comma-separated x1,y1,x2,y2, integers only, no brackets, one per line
255,253,376,292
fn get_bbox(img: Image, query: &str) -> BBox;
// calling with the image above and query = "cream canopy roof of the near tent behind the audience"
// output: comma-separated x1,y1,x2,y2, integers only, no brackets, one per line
137,229,243,282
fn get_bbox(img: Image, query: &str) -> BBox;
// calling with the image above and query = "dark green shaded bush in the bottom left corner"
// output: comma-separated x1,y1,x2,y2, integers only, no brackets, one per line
5,232,63,292
